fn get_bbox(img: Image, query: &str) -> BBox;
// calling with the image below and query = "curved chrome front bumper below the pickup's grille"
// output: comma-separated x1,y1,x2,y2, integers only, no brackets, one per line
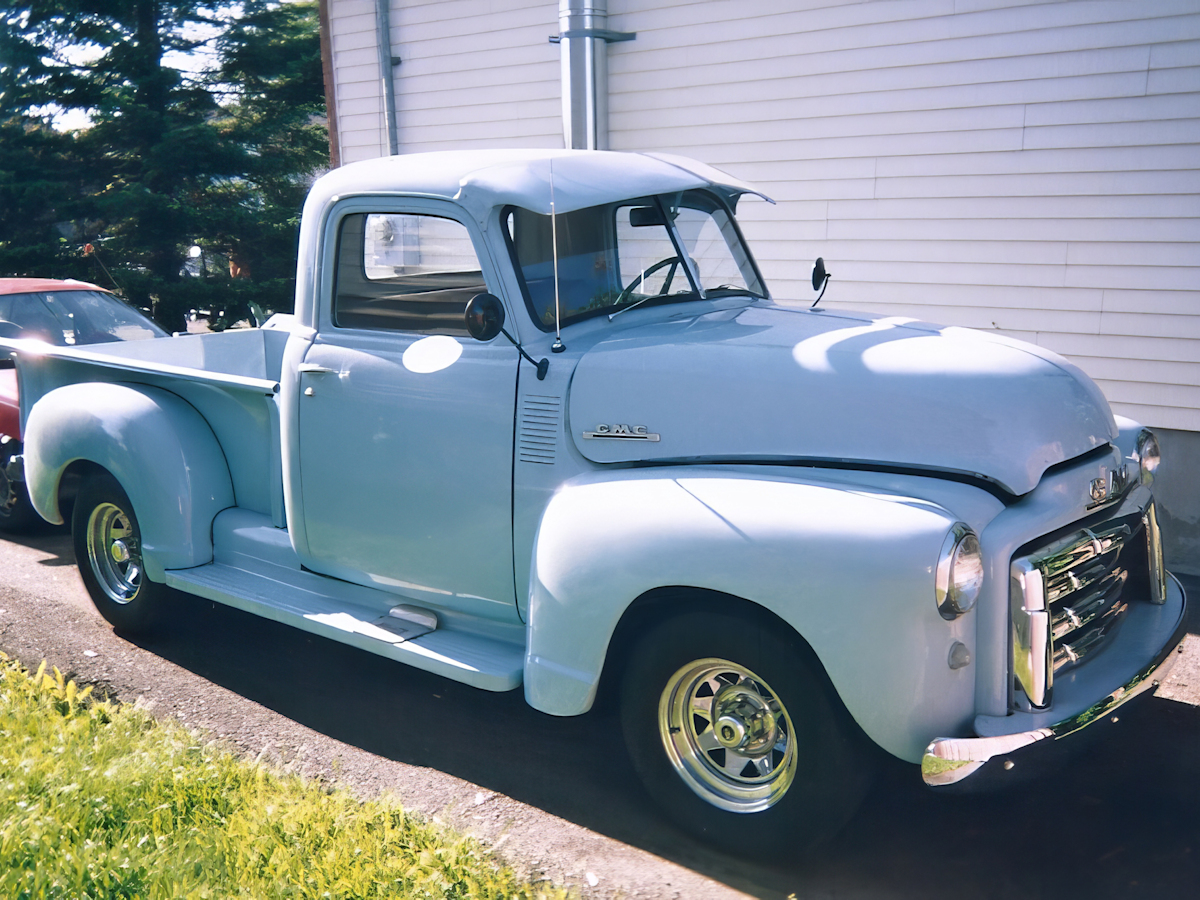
920,576,1187,787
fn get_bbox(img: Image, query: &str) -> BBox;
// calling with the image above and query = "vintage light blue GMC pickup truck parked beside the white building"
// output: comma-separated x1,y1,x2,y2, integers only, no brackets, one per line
5,151,1184,852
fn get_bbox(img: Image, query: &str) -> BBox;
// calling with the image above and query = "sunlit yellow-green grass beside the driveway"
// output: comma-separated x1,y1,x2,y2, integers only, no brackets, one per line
0,653,566,900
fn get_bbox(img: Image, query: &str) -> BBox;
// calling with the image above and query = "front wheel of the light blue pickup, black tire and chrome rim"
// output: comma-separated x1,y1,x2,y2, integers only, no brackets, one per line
620,606,871,858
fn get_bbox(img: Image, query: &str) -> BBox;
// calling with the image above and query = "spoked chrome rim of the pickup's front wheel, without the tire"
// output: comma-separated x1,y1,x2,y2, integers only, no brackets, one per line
659,659,796,812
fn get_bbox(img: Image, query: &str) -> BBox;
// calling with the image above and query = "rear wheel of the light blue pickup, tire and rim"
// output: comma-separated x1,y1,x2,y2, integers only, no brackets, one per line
71,472,170,635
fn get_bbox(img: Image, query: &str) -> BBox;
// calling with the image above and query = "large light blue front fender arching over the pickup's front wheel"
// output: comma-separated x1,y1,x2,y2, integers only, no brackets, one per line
524,467,974,760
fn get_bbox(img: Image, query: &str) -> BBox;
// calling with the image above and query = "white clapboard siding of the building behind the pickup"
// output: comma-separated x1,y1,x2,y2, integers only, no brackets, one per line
330,0,1200,430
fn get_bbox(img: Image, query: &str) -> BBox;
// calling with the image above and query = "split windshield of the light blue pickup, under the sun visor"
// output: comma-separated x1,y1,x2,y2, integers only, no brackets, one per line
504,191,767,330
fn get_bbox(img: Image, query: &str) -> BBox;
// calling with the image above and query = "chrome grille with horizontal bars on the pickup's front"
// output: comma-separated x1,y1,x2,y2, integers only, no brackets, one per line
1010,504,1162,709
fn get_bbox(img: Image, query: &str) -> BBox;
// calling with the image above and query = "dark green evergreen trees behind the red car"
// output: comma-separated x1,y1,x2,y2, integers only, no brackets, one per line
0,0,328,330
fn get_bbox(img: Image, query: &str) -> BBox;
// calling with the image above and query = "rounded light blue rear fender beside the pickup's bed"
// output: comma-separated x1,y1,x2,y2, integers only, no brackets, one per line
25,383,234,581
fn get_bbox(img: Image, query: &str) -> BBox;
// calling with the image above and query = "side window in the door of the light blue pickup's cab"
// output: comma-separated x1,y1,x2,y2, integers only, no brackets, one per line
334,212,487,335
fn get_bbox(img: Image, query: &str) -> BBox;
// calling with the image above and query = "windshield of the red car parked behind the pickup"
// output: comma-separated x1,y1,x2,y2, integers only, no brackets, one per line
0,290,167,347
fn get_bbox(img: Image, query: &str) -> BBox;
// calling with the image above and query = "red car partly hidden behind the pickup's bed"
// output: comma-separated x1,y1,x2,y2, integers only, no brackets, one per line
0,278,167,532
